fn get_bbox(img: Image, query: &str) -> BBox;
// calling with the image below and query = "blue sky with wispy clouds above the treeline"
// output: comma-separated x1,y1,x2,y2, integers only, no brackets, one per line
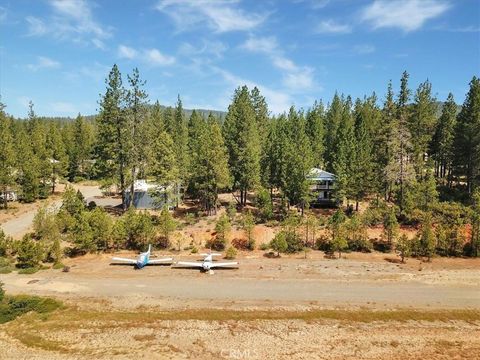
0,0,480,117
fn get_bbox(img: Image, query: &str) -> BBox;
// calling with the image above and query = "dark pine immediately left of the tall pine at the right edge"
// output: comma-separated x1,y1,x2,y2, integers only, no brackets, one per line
430,93,457,185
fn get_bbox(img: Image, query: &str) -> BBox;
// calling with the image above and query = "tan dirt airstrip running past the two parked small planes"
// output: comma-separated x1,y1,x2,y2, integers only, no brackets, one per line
2,254,480,309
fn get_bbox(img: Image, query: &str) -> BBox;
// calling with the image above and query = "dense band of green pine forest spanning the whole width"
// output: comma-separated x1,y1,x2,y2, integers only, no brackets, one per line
0,65,480,268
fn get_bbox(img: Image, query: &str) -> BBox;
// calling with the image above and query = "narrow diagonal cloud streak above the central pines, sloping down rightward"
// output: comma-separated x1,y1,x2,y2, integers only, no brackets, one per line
241,37,314,91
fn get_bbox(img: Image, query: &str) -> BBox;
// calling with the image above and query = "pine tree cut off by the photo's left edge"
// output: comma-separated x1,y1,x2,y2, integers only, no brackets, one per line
0,103,15,209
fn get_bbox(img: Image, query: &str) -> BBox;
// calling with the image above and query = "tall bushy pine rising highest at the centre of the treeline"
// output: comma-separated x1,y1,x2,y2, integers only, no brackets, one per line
223,86,261,205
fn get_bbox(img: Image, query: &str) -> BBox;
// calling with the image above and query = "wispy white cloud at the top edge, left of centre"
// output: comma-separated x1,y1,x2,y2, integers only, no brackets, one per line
156,0,266,32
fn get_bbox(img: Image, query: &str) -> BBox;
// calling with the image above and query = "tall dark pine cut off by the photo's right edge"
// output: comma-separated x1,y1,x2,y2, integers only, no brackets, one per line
454,76,480,194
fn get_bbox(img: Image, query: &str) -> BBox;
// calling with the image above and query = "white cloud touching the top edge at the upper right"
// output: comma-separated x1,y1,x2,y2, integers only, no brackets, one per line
361,0,450,32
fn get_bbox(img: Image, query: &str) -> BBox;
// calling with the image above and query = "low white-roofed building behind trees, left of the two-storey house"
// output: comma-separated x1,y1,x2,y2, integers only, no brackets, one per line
125,179,175,209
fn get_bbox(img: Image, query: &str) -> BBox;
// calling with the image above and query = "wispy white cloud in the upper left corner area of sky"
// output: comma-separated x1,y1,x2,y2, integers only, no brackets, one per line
25,0,112,49
